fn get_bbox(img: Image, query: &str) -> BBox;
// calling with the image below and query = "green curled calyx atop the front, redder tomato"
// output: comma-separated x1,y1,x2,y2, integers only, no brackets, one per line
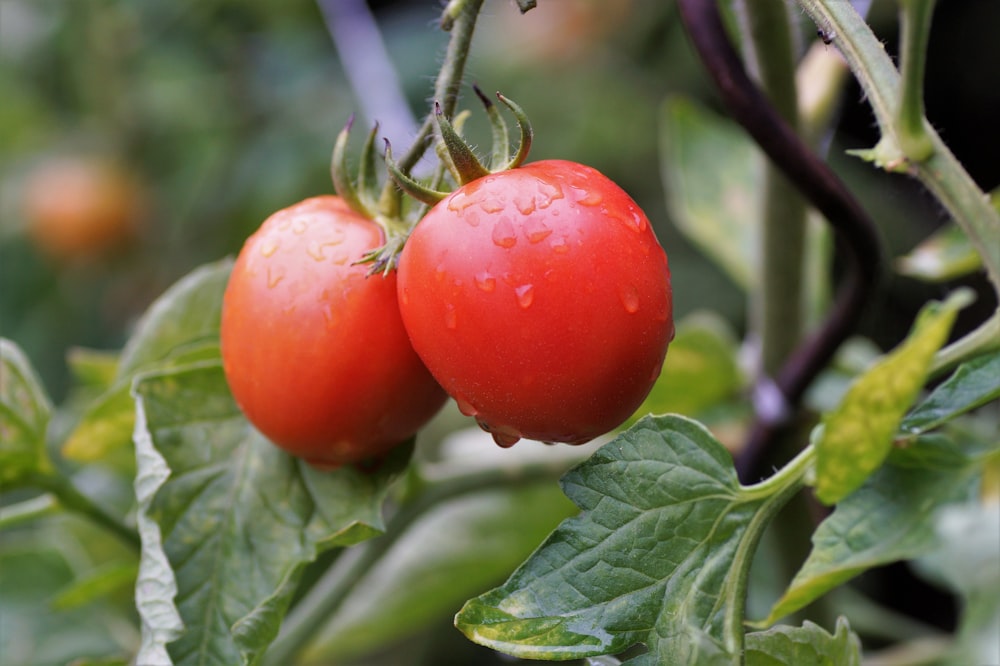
385,86,532,205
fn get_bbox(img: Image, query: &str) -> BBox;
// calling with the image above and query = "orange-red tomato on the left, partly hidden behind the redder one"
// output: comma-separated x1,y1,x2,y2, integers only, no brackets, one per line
220,196,446,468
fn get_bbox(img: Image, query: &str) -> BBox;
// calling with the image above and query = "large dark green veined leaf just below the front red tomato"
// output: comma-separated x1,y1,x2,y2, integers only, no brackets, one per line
455,415,804,664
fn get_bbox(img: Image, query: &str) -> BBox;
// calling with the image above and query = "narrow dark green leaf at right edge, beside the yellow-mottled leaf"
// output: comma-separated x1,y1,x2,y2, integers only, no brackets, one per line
899,351,1000,437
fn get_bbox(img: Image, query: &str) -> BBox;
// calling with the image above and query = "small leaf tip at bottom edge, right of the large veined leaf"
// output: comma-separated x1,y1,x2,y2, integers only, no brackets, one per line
746,617,861,666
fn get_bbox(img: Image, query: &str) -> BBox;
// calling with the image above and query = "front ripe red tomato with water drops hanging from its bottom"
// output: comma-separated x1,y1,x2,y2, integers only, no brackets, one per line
398,160,674,445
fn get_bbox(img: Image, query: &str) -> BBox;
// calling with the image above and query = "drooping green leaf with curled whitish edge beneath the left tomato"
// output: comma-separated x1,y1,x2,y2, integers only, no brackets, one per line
133,363,409,666
